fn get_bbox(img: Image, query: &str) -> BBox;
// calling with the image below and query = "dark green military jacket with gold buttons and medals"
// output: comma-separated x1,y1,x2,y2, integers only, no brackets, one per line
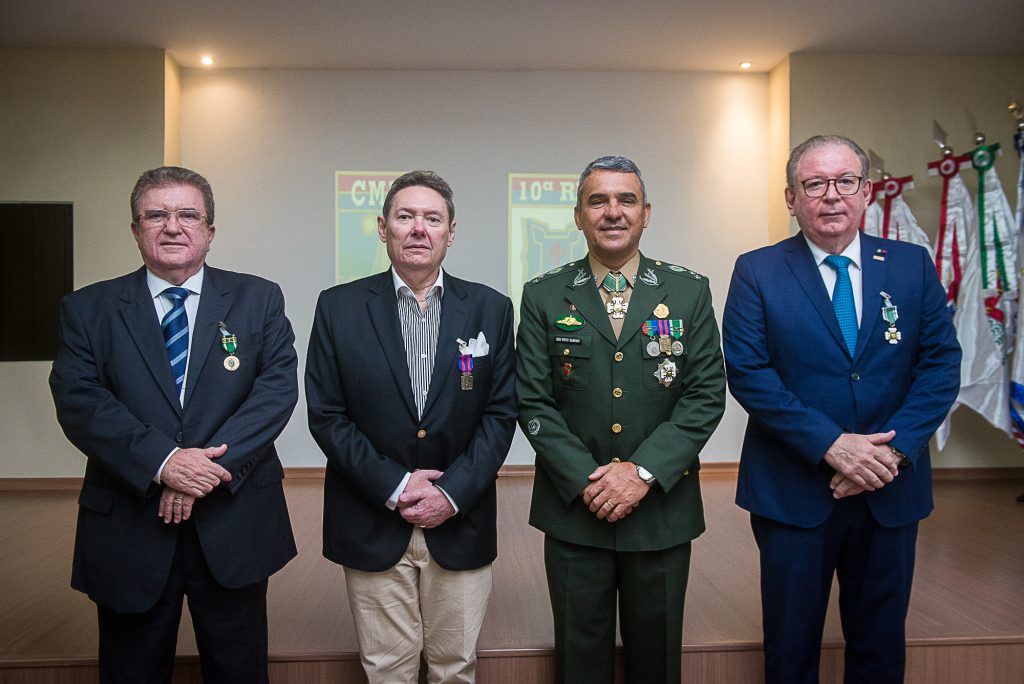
516,255,725,551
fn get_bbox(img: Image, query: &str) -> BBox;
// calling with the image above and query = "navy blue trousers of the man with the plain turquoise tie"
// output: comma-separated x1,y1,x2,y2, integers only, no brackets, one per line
751,495,918,684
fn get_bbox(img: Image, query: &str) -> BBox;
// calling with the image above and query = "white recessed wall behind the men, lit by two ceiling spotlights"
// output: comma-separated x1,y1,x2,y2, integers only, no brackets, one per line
182,70,768,466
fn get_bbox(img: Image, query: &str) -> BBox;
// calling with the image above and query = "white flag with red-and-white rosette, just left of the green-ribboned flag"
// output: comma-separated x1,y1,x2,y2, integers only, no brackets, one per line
929,157,1011,450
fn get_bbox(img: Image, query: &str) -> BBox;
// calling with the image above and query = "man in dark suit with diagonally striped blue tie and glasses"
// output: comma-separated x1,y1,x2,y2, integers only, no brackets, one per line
50,167,298,683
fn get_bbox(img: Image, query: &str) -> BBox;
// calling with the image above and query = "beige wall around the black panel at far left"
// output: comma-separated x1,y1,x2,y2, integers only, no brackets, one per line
0,48,164,477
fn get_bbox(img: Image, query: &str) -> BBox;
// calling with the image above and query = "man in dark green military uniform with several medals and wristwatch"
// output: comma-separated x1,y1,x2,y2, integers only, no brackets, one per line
517,157,725,684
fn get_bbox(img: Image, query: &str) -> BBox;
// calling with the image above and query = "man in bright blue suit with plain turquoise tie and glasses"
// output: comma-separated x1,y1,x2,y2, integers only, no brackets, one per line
723,136,961,684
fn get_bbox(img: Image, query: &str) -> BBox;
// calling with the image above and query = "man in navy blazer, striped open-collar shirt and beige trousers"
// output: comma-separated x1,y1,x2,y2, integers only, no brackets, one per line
305,171,516,684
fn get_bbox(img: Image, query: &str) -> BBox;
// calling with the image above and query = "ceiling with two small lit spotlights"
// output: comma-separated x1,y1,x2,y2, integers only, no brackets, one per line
0,0,1024,73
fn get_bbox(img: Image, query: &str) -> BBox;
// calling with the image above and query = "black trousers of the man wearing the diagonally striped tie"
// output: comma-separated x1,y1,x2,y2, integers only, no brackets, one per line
96,522,268,684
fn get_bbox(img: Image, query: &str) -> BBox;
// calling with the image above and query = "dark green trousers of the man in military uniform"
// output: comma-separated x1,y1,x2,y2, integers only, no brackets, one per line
544,537,690,684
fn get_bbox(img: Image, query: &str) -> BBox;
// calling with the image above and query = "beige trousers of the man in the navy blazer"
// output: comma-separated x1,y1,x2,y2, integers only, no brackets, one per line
345,527,490,684
